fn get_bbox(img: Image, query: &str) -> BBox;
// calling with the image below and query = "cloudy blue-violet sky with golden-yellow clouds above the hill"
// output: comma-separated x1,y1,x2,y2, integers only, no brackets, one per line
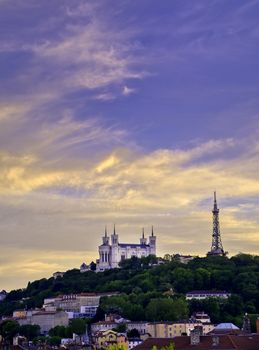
0,0,259,290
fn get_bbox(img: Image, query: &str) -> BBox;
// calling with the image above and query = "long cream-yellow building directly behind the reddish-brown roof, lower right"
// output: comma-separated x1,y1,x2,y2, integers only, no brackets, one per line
147,320,214,338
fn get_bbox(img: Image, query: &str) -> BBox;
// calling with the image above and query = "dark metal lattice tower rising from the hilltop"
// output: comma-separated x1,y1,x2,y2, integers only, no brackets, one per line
207,192,226,256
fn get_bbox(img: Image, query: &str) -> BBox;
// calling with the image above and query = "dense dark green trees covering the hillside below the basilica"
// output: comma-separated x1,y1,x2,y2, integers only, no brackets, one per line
0,254,259,325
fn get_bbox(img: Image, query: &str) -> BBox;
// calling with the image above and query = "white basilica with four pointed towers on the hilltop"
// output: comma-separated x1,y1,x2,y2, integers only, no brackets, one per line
96,226,156,272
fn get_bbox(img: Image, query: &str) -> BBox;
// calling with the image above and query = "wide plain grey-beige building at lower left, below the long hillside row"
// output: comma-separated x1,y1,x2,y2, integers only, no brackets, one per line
16,311,68,335
